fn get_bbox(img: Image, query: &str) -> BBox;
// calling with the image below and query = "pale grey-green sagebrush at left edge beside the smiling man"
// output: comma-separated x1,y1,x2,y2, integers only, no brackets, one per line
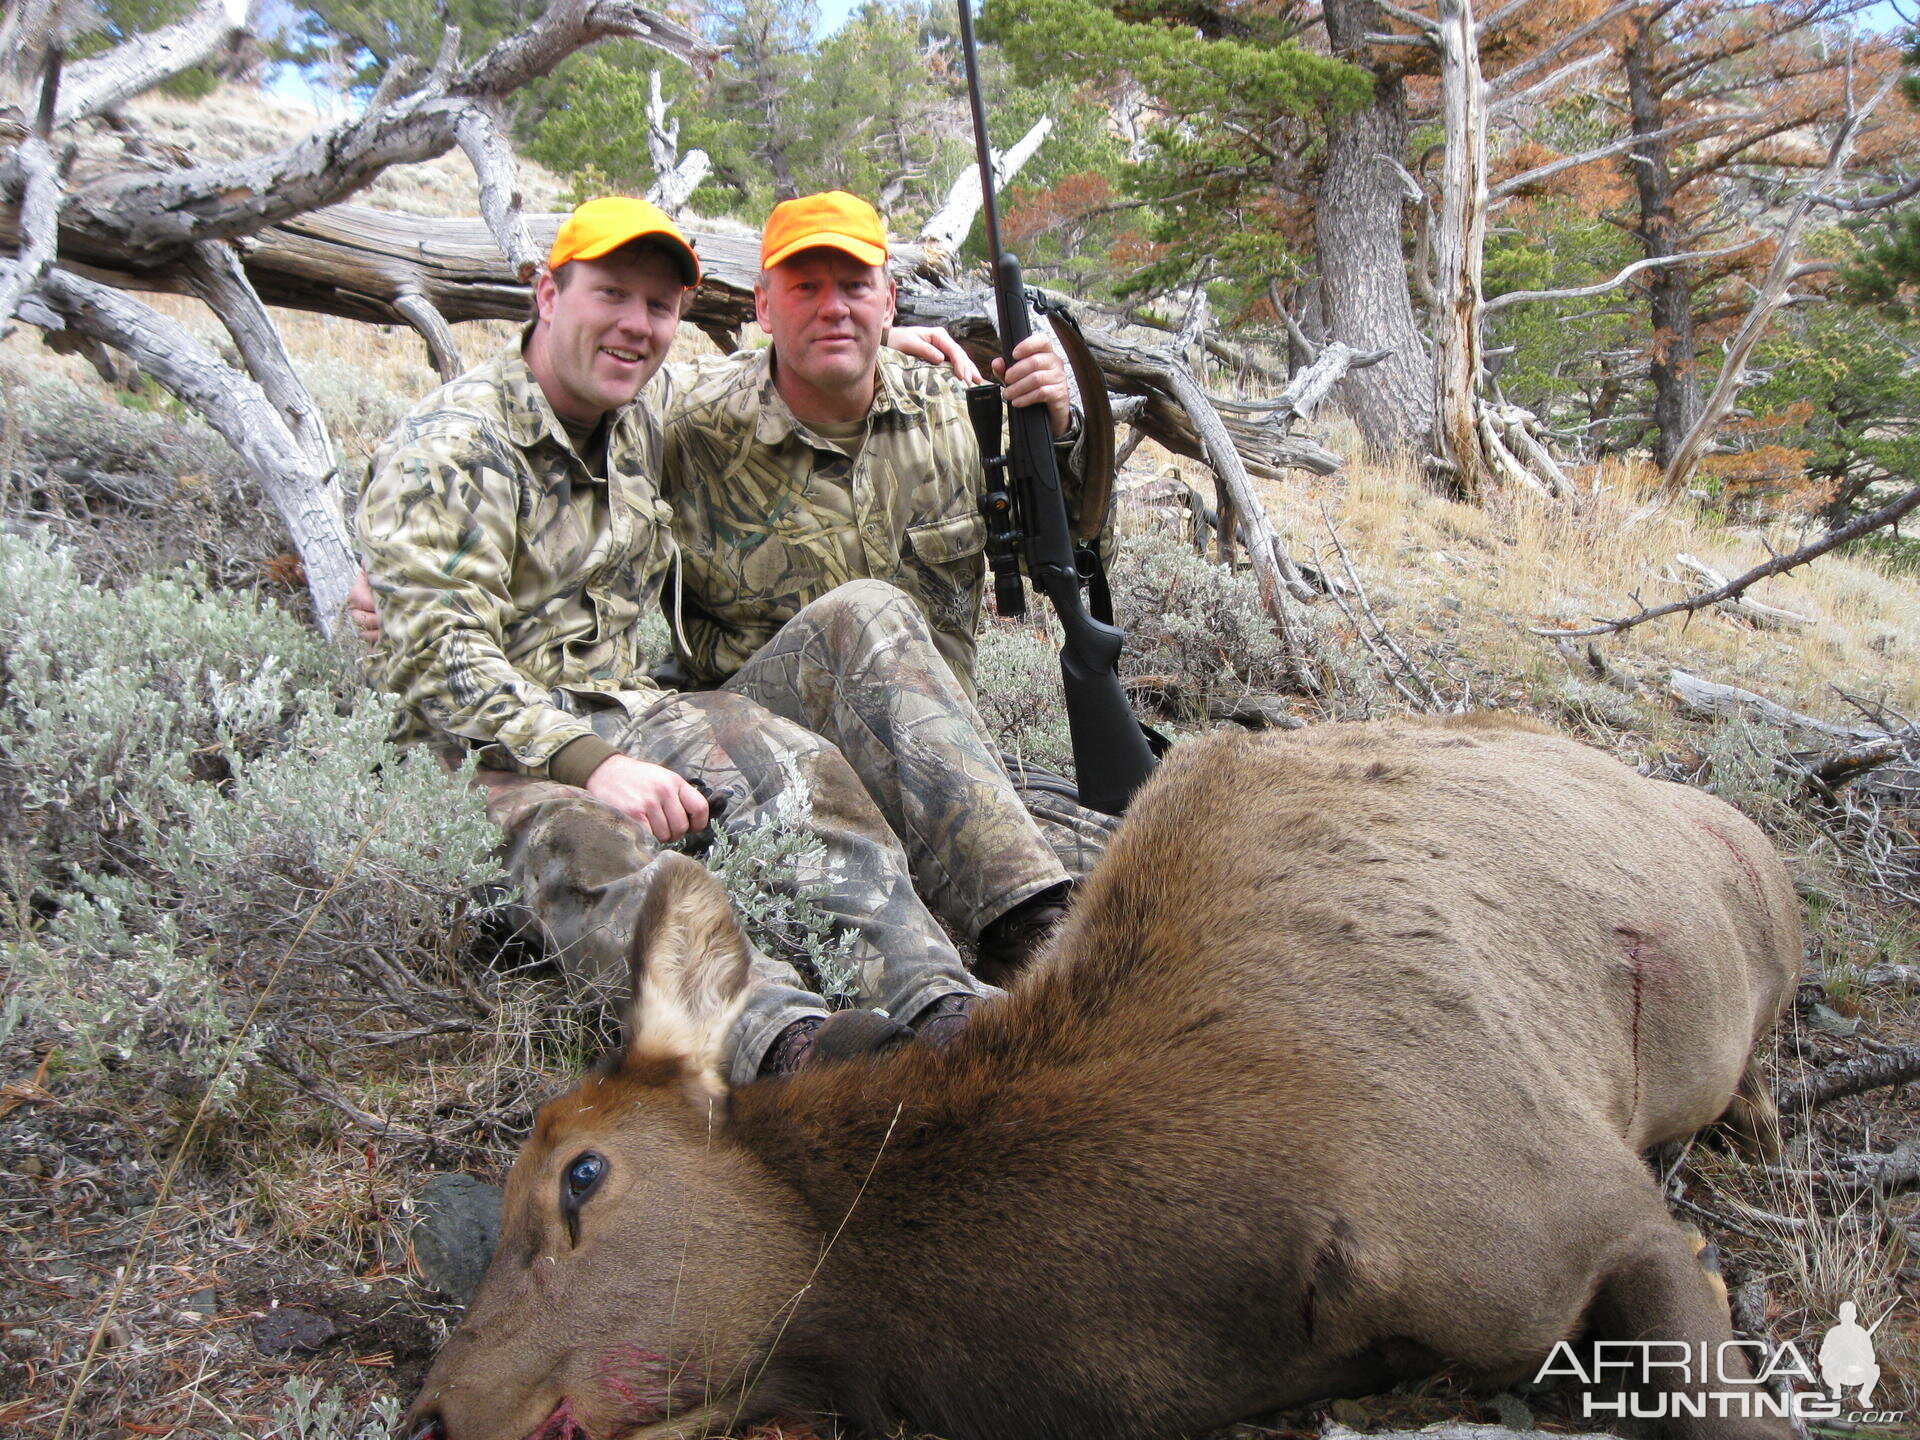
0,534,495,1100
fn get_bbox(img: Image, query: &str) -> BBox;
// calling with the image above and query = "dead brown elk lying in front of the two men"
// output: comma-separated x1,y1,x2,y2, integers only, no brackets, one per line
413,716,1799,1440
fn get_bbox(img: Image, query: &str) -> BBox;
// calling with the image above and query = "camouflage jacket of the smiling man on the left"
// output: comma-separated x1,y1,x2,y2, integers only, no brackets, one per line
346,342,674,776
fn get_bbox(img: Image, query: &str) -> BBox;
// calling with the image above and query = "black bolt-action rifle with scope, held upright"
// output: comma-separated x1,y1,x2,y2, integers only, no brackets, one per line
960,0,1154,814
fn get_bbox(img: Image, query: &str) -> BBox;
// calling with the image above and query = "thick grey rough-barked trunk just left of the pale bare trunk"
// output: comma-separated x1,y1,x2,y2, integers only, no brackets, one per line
1313,0,1434,455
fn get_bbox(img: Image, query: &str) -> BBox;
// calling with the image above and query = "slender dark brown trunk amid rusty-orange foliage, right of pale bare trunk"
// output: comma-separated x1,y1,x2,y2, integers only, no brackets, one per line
1622,17,1701,468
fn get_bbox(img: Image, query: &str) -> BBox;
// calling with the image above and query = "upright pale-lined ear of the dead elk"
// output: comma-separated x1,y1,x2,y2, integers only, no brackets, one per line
626,851,749,1096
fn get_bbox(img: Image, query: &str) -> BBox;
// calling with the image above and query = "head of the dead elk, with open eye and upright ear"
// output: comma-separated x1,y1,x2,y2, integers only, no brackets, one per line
401,854,818,1440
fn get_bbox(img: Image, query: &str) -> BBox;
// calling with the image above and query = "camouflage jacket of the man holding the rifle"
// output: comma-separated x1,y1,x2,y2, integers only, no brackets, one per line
662,349,1090,691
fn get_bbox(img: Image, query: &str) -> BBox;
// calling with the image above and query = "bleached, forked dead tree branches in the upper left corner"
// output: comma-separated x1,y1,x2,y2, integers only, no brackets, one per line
0,0,718,634
